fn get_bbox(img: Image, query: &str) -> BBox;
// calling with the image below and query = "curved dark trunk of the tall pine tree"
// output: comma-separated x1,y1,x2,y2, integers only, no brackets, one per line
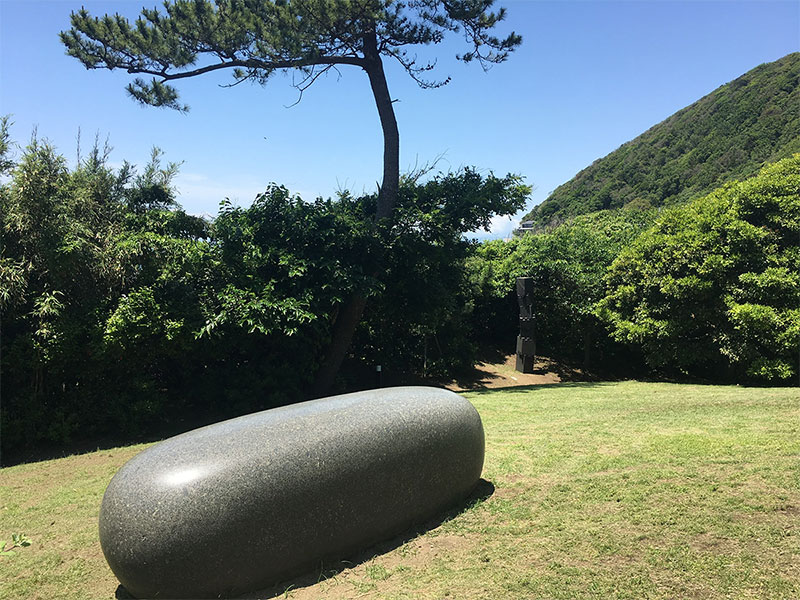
312,32,400,397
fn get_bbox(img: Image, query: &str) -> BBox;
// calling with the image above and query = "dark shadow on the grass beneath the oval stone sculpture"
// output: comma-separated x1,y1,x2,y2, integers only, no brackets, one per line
115,479,495,600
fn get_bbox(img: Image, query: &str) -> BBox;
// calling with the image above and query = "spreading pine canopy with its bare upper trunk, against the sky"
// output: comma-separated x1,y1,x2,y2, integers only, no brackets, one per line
61,0,521,217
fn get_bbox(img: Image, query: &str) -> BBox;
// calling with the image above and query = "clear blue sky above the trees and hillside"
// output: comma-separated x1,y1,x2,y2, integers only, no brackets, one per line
0,0,800,237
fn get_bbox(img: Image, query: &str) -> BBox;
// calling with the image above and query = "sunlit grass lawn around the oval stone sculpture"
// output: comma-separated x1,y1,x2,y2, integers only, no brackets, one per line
0,382,800,600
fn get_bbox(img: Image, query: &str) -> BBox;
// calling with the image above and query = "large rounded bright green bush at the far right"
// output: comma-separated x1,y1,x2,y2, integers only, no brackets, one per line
598,154,800,382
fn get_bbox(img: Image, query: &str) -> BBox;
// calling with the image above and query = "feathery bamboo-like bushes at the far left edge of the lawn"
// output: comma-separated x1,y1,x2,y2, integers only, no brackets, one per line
0,131,207,448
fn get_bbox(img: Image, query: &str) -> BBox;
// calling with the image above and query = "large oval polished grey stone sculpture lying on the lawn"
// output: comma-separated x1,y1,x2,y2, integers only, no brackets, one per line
100,387,484,598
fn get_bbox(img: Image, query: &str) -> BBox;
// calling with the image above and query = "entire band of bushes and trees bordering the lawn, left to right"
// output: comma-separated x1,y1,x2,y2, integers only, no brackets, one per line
7,67,800,451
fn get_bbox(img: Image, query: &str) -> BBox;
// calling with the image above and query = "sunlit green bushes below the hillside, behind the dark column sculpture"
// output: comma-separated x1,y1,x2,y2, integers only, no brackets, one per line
467,154,800,383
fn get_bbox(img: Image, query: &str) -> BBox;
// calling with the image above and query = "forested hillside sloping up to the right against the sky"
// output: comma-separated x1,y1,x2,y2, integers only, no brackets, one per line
523,52,800,230
